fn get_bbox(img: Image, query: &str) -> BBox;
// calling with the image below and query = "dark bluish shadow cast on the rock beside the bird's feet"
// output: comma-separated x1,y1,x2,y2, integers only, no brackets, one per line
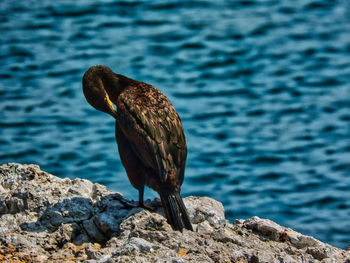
20,193,149,247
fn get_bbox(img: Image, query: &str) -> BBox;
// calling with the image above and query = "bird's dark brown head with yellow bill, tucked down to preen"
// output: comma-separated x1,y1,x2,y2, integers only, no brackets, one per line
83,66,120,118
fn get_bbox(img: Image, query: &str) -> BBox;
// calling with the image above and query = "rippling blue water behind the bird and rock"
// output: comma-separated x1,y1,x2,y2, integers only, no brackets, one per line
0,0,350,248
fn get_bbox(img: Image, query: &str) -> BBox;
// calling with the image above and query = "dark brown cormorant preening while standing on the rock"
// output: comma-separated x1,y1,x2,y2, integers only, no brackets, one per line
82,65,193,232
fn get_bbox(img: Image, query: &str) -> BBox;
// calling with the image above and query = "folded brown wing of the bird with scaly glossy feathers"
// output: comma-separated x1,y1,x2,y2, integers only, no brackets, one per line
117,84,187,185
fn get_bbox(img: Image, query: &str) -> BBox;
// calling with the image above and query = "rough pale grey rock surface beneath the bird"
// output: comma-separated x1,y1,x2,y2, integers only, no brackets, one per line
0,164,350,263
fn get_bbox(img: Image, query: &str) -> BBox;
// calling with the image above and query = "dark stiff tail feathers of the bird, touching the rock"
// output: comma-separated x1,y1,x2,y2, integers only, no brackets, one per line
160,191,193,232
